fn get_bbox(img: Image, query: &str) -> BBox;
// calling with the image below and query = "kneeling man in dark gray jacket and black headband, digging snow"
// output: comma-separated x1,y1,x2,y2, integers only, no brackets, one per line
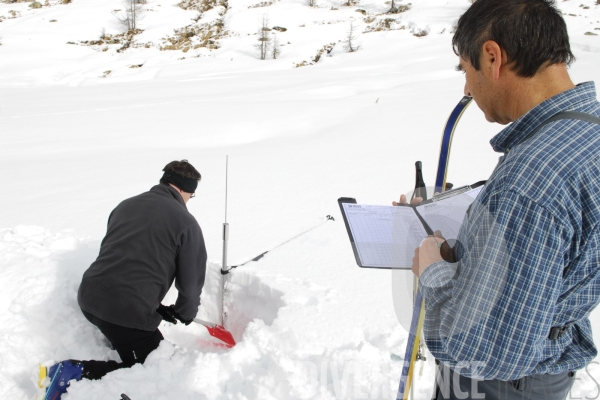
39,160,206,398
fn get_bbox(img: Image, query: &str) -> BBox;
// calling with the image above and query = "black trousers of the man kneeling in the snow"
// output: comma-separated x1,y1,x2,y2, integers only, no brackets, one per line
79,310,164,379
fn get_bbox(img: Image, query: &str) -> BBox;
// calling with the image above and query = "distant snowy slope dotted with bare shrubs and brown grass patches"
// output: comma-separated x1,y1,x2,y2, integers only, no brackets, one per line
0,0,474,84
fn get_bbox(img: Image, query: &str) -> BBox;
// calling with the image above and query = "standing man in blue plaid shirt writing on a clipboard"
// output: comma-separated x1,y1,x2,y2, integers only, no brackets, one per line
413,0,600,400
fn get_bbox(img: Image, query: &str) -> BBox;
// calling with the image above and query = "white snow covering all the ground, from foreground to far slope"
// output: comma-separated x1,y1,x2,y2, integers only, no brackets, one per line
0,0,600,400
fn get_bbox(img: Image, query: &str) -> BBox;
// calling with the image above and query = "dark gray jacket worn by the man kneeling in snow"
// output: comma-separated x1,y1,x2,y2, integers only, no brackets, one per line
77,184,206,331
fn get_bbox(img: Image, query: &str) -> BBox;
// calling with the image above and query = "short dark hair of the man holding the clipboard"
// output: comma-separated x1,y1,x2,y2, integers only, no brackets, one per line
452,0,575,78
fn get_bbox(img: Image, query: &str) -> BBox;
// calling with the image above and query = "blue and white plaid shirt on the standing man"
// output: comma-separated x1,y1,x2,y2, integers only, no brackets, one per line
419,82,600,380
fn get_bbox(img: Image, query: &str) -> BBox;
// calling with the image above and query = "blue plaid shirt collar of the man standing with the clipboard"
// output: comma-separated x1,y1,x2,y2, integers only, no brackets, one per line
490,82,596,153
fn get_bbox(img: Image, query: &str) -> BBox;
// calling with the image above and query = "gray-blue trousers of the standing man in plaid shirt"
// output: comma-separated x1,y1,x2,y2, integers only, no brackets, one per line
436,363,575,400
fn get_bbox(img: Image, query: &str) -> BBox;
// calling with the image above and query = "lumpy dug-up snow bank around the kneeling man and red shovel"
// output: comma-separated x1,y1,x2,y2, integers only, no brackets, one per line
0,226,412,400
